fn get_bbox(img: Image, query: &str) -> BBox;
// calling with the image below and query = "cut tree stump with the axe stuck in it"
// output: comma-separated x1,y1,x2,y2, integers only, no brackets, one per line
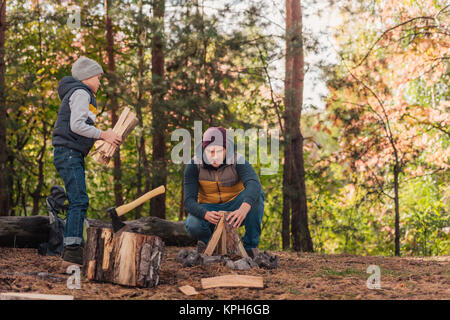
83,227,164,287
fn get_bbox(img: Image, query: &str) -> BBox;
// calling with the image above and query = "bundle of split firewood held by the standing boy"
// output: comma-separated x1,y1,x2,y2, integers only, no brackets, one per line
92,108,139,165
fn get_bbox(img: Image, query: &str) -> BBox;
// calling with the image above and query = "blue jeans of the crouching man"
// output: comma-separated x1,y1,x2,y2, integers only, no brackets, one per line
184,190,264,250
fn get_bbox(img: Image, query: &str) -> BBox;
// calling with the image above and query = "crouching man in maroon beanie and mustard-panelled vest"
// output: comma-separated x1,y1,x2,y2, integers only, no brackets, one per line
184,127,264,255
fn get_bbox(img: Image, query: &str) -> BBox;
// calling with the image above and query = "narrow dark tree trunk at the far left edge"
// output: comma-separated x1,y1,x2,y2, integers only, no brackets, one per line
0,0,10,216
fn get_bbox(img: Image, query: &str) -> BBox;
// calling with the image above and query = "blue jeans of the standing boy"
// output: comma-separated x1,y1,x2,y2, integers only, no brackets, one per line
53,146,89,246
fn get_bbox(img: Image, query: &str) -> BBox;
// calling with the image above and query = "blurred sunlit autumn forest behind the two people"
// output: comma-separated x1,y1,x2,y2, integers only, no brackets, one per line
0,0,450,255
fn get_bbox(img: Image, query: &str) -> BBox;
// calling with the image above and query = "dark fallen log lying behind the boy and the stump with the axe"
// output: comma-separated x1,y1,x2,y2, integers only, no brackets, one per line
0,216,197,248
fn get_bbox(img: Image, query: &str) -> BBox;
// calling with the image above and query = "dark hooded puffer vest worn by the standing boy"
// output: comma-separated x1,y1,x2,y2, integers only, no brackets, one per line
52,77,97,156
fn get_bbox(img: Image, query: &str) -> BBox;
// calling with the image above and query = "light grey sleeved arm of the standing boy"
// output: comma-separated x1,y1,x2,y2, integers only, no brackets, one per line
69,89,102,139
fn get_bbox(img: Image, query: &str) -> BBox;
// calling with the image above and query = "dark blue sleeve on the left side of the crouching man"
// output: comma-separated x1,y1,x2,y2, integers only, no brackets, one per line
184,161,207,219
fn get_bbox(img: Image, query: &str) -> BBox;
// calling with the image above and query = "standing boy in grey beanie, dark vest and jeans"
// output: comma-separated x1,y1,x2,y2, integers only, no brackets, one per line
52,57,122,264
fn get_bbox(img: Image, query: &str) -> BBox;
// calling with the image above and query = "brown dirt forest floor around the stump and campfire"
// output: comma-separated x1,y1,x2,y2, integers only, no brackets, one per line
0,247,450,300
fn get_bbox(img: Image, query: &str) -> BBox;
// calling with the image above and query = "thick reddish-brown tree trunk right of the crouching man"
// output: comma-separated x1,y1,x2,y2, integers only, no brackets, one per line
285,0,313,252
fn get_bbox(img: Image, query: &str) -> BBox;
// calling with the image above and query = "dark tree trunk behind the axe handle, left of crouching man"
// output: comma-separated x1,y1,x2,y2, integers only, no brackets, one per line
150,0,167,219
